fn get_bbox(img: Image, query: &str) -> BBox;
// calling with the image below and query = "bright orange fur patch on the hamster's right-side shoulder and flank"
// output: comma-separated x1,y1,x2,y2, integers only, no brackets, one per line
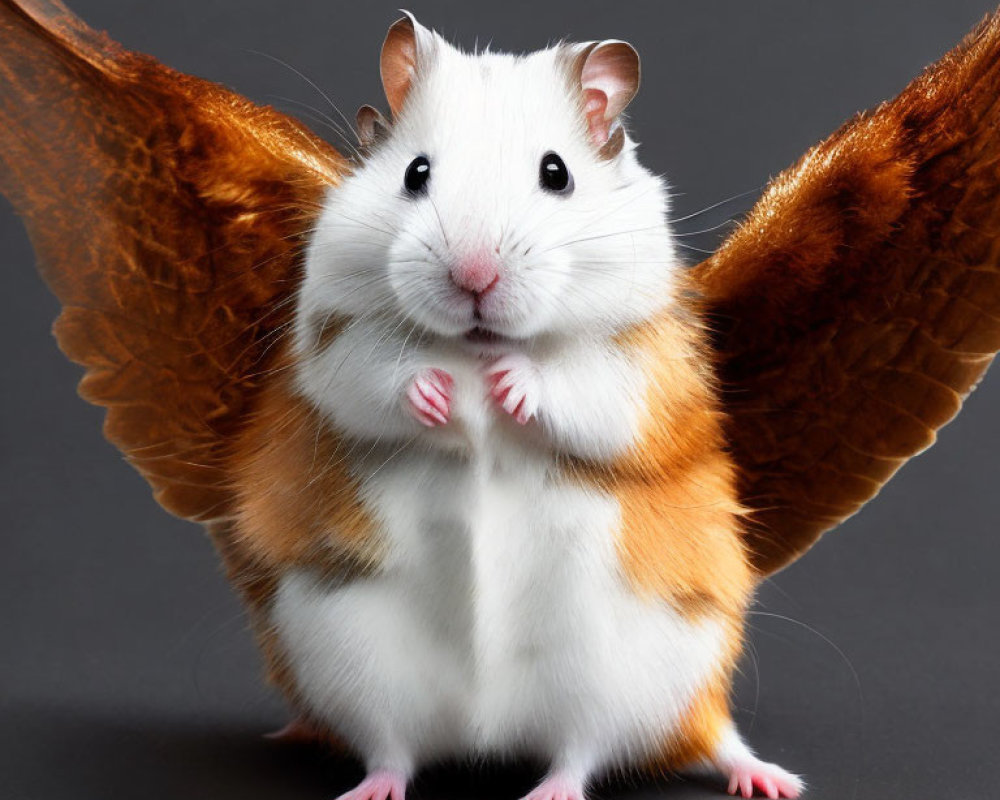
568,296,751,619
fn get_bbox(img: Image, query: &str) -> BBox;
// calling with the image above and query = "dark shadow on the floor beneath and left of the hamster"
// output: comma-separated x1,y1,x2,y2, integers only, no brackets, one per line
0,703,724,800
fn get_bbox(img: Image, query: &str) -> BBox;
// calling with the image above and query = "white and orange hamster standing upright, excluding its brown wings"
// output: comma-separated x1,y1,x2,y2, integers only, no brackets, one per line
266,16,802,800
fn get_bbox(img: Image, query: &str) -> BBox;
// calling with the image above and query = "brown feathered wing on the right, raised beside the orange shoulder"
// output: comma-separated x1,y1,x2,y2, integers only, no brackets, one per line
693,12,1000,573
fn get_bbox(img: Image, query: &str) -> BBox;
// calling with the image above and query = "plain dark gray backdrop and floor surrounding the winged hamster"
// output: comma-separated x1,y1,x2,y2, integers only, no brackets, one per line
0,0,1000,800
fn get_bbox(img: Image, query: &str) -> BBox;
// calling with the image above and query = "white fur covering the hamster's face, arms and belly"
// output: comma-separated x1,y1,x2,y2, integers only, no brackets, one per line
271,17,740,781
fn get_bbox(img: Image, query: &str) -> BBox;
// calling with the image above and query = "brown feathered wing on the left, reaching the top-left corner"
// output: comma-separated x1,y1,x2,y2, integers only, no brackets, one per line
0,0,343,520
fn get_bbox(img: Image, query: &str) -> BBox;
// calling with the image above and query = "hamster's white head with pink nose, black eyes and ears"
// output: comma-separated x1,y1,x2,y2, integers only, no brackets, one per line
299,16,677,348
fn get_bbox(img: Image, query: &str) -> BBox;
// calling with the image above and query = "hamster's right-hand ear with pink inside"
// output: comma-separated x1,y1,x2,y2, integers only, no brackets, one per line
579,39,639,149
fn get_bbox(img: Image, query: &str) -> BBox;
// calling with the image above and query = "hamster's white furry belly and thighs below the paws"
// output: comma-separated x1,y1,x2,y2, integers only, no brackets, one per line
272,444,724,768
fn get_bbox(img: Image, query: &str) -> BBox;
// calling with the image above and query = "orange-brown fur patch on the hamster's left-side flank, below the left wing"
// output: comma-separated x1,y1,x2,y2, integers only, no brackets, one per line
202,346,381,704
